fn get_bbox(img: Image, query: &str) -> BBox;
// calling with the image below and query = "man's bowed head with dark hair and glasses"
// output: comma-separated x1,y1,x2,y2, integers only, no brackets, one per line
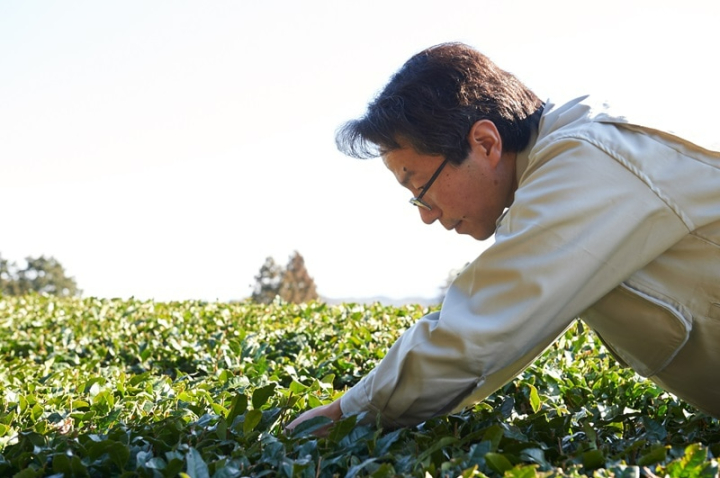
336,43,542,239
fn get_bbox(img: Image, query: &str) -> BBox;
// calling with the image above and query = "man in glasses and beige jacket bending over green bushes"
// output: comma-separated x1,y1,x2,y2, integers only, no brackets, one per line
289,44,720,428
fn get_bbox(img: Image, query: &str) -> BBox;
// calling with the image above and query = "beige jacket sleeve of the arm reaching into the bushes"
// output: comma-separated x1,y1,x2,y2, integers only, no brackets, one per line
341,129,688,426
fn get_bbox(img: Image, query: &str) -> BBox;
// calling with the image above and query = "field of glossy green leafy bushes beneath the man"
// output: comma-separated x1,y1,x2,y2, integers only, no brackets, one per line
0,295,720,478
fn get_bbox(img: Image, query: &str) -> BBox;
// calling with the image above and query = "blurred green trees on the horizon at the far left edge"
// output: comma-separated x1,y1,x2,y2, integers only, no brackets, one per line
0,252,82,297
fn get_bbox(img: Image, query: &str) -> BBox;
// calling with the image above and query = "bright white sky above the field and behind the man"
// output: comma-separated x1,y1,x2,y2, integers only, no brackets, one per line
0,0,720,301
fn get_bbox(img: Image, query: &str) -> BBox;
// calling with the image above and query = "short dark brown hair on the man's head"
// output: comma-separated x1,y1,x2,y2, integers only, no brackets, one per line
336,43,542,164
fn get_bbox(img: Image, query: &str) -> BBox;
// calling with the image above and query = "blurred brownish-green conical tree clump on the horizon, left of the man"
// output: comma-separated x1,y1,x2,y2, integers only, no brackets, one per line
251,251,318,304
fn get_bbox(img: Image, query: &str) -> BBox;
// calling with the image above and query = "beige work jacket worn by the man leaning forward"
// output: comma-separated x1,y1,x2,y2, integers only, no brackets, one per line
340,98,720,426
